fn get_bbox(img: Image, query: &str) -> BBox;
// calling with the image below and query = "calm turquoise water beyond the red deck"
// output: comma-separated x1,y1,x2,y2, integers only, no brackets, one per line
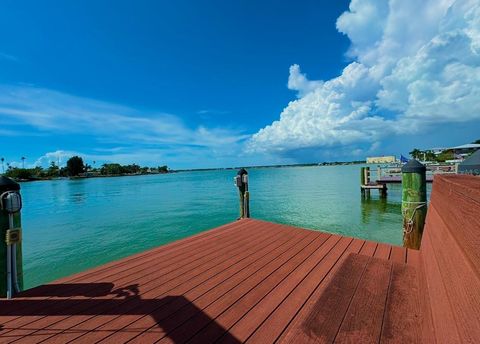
21,165,426,288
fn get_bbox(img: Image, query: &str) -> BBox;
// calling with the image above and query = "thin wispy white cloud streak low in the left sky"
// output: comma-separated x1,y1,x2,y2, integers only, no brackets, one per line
0,85,250,167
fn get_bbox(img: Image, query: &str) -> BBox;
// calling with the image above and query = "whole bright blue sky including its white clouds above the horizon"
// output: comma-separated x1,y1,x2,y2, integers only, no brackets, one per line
0,0,480,168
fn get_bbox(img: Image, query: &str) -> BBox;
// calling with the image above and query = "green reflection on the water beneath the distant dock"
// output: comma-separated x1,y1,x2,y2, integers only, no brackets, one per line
360,195,402,224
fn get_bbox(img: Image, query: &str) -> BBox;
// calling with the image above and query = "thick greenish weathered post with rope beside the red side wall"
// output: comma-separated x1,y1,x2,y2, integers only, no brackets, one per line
402,159,427,250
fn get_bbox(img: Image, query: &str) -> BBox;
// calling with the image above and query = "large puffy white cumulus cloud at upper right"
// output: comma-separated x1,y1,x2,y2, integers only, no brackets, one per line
247,0,480,156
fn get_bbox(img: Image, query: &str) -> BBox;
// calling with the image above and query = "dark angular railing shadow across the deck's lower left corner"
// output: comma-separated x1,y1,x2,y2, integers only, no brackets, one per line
0,283,240,343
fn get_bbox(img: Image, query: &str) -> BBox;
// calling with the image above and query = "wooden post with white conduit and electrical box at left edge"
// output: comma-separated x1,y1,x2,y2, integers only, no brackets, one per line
0,176,23,298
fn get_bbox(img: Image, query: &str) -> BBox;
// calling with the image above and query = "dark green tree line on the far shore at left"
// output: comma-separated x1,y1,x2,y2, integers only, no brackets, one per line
2,156,170,180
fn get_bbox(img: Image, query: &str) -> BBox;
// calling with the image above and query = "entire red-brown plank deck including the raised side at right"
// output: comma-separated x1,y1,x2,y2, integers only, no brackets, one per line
0,176,480,344
